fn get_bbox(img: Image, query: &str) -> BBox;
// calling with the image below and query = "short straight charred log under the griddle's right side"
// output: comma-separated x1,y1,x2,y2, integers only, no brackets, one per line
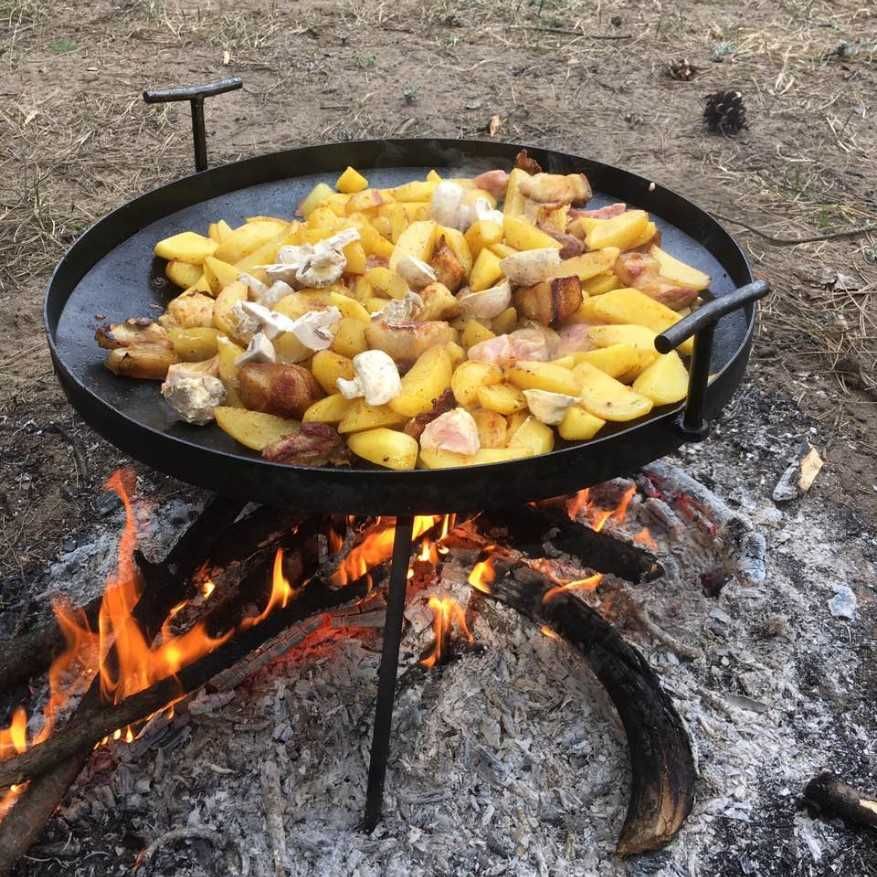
479,506,664,584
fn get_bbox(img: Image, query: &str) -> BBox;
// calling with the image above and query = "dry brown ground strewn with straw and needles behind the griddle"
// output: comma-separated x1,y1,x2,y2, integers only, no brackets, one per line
0,0,877,580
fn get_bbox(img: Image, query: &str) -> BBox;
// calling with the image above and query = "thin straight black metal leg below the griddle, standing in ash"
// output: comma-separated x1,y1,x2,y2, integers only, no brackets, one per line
363,515,414,831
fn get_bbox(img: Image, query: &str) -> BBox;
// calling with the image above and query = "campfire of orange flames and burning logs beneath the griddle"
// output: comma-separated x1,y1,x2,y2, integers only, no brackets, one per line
0,464,776,871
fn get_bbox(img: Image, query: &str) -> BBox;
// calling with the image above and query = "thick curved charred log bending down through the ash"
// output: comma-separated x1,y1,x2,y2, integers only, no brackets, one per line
470,570,695,857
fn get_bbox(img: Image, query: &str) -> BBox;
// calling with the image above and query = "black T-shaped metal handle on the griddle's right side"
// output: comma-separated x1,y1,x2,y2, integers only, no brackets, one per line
655,280,770,441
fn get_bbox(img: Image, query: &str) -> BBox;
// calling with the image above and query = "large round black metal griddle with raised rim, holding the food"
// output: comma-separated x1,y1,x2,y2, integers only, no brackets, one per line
45,140,755,514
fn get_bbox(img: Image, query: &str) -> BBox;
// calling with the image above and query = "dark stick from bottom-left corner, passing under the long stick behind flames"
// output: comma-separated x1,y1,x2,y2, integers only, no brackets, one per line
0,497,242,877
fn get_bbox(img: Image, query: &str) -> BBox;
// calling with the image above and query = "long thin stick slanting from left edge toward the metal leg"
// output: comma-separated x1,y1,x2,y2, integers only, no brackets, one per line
0,581,367,792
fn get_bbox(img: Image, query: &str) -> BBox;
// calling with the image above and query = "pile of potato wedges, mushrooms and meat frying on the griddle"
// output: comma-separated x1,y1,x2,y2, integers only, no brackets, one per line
96,151,710,469
